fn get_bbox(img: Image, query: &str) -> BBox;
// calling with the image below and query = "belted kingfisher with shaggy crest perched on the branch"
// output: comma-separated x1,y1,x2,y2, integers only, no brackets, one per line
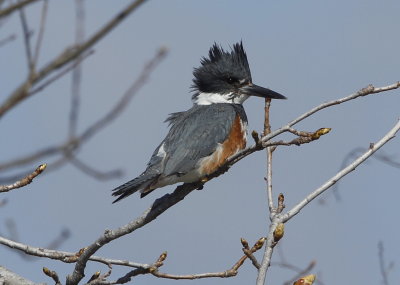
112,42,286,203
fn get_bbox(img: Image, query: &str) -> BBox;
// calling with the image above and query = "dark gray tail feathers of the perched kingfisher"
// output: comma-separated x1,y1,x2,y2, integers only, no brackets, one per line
112,173,160,204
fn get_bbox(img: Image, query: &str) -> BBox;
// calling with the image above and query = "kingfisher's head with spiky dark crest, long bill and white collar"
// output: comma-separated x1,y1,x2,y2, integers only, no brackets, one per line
192,42,286,105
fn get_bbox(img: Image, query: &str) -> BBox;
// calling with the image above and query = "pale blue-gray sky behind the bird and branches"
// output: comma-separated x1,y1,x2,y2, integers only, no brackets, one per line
0,0,400,284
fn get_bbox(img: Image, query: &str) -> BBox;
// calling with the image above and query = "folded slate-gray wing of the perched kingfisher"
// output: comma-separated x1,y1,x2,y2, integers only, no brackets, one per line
163,104,236,176
